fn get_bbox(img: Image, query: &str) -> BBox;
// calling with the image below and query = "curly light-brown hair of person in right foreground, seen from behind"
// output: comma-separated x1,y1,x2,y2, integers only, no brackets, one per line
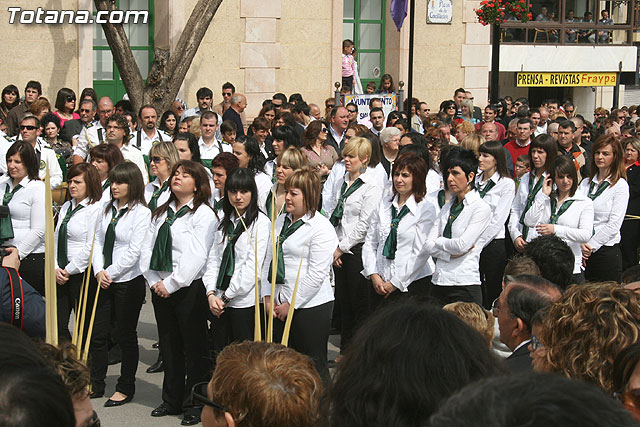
539,282,640,394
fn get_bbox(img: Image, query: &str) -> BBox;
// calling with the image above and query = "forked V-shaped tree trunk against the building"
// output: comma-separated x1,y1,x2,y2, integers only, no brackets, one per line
94,0,222,114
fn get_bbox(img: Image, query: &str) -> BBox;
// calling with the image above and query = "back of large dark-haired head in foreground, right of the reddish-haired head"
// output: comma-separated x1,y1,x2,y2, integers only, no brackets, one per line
329,299,505,427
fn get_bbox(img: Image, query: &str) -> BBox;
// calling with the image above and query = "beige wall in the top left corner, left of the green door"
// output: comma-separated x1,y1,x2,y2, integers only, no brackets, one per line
0,0,78,100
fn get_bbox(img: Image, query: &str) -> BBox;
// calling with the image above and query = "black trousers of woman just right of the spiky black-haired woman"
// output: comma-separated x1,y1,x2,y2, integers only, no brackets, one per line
480,239,507,309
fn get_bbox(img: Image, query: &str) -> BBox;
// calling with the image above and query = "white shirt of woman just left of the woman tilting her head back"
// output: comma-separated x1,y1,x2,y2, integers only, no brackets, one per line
92,200,151,282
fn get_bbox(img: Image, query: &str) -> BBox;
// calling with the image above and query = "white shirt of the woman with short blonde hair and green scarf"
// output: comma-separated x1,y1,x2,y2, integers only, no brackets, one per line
328,168,383,253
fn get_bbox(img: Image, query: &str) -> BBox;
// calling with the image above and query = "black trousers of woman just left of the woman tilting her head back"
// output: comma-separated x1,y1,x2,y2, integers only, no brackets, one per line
85,276,146,396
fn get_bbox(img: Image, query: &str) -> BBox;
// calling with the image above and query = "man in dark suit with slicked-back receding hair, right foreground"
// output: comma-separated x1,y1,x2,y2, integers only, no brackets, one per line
493,275,561,373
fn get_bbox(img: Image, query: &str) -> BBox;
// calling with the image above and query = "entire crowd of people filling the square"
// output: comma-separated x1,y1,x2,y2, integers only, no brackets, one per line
0,76,640,426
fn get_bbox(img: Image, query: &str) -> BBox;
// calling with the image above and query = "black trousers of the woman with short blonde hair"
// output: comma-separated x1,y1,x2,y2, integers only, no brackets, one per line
333,244,375,353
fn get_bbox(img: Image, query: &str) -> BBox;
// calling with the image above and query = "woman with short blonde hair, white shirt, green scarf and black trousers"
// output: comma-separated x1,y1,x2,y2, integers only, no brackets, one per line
329,137,383,352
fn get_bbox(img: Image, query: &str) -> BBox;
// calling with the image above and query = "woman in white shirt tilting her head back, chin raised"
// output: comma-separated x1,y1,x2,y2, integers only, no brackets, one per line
140,160,217,425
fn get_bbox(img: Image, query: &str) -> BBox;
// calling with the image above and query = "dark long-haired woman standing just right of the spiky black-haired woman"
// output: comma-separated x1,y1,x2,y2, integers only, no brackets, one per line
476,141,516,307
